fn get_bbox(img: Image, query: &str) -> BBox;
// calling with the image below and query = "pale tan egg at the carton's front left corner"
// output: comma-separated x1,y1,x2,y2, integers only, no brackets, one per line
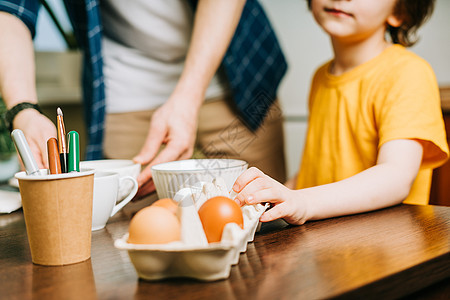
128,206,181,244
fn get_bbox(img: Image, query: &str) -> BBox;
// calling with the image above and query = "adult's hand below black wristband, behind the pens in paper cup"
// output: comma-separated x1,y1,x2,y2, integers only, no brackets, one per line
13,109,56,168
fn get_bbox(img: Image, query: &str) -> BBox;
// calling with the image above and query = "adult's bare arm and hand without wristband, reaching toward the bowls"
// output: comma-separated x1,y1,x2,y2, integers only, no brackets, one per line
134,0,245,195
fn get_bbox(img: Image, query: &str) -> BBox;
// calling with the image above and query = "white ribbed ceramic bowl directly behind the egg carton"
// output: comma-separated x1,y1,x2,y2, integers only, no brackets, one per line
152,159,248,199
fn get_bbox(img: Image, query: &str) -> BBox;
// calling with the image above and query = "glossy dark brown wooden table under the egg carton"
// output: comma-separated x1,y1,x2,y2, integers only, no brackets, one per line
0,205,450,300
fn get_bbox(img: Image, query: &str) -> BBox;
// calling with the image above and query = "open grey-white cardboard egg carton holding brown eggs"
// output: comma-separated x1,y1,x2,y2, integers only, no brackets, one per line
114,178,267,281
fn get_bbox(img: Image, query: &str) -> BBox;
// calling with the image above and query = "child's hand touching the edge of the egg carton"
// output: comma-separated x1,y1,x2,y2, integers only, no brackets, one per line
233,168,306,225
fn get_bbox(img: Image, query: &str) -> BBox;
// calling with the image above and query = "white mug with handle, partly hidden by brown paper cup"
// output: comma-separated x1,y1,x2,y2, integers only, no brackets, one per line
92,171,138,230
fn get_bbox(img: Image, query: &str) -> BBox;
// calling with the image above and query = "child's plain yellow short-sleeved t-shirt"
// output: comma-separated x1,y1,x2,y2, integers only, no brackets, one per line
297,45,449,204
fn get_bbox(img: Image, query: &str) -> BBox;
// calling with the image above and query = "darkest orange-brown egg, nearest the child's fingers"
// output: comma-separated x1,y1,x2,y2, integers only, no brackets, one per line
198,196,244,243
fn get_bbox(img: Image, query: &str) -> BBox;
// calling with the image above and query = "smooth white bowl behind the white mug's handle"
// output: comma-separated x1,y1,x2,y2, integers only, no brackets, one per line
80,159,141,201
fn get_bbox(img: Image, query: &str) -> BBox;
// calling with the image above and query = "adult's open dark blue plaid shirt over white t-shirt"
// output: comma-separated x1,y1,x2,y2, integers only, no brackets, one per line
0,0,287,159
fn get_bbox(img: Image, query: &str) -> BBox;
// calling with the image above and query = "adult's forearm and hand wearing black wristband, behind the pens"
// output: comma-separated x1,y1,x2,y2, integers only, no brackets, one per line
0,12,56,168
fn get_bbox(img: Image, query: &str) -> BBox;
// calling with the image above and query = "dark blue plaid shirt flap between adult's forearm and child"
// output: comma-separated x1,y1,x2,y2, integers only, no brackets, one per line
223,0,287,130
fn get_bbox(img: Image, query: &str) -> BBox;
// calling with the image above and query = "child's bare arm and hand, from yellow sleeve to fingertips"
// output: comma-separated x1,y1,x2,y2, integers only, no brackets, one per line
233,140,423,224
